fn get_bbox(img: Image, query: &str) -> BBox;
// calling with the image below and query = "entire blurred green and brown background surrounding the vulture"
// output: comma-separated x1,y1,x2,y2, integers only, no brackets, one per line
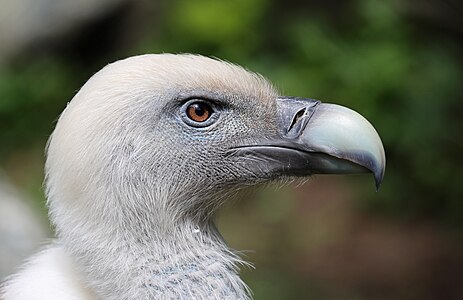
0,0,463,299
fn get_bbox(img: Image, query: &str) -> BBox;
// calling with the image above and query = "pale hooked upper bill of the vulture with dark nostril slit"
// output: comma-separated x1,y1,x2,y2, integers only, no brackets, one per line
280,98,386,190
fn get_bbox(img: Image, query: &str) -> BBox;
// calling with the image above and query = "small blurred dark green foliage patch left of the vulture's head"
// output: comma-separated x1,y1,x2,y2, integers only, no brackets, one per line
0,58,76,157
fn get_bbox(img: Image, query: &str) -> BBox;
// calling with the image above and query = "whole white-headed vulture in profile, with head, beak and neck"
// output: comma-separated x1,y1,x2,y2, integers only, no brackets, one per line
1,54,385,300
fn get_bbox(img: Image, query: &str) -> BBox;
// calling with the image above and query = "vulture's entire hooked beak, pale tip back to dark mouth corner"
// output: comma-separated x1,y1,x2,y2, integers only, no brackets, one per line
230,97,386,189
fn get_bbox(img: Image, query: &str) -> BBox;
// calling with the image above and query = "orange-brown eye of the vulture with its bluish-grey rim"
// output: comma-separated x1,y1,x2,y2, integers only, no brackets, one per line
181,99,219,127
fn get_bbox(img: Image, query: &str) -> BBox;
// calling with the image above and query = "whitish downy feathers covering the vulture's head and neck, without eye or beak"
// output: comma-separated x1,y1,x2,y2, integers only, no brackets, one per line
42,54,277,299
